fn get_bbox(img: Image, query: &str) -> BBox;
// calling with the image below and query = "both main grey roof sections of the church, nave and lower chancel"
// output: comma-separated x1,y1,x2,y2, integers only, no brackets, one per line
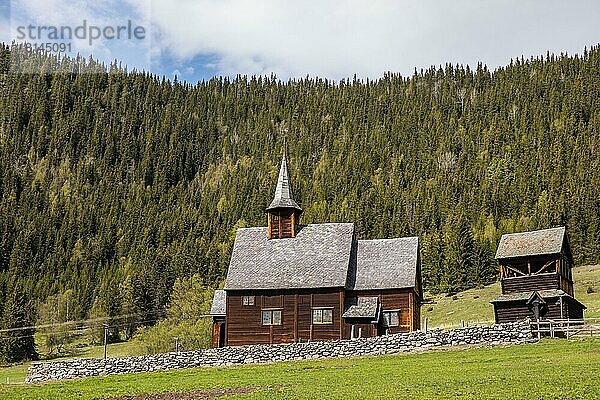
225,223,419,290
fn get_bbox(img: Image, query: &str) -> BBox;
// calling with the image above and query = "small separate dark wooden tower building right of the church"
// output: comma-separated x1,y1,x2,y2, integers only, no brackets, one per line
491,227,586,324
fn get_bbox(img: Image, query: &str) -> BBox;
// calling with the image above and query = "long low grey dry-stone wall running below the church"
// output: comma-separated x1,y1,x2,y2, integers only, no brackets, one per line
26,323,533,383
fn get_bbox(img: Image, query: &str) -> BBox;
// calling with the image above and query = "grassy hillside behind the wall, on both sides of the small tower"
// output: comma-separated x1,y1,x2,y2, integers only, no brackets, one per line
421,265,600,328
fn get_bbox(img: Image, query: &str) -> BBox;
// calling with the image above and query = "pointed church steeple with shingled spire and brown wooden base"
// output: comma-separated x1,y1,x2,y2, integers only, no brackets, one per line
266,147,302,239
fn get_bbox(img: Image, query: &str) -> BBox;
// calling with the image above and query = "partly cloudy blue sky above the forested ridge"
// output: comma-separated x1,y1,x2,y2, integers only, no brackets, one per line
0,0,600,83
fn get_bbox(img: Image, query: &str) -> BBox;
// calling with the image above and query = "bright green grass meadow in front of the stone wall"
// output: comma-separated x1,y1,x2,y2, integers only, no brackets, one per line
0,338,600,400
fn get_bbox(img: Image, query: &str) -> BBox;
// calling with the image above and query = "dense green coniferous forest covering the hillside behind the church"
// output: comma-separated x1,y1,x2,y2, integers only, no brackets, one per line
0,45,600,359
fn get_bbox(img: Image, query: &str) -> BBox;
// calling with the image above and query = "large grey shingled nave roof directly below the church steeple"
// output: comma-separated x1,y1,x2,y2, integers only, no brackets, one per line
225,223,354,290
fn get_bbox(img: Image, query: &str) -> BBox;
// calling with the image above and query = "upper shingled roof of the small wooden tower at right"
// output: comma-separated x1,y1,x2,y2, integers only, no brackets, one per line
496,226,565,259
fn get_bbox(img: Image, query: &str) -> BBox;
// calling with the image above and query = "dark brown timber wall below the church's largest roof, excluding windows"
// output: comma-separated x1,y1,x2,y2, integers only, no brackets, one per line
227,289,344,346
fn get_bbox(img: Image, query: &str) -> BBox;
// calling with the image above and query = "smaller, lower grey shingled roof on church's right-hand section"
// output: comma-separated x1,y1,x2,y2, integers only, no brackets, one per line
347,237,419,290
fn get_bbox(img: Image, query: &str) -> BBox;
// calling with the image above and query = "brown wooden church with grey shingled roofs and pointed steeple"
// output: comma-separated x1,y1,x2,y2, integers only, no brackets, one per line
211,153,422,347
